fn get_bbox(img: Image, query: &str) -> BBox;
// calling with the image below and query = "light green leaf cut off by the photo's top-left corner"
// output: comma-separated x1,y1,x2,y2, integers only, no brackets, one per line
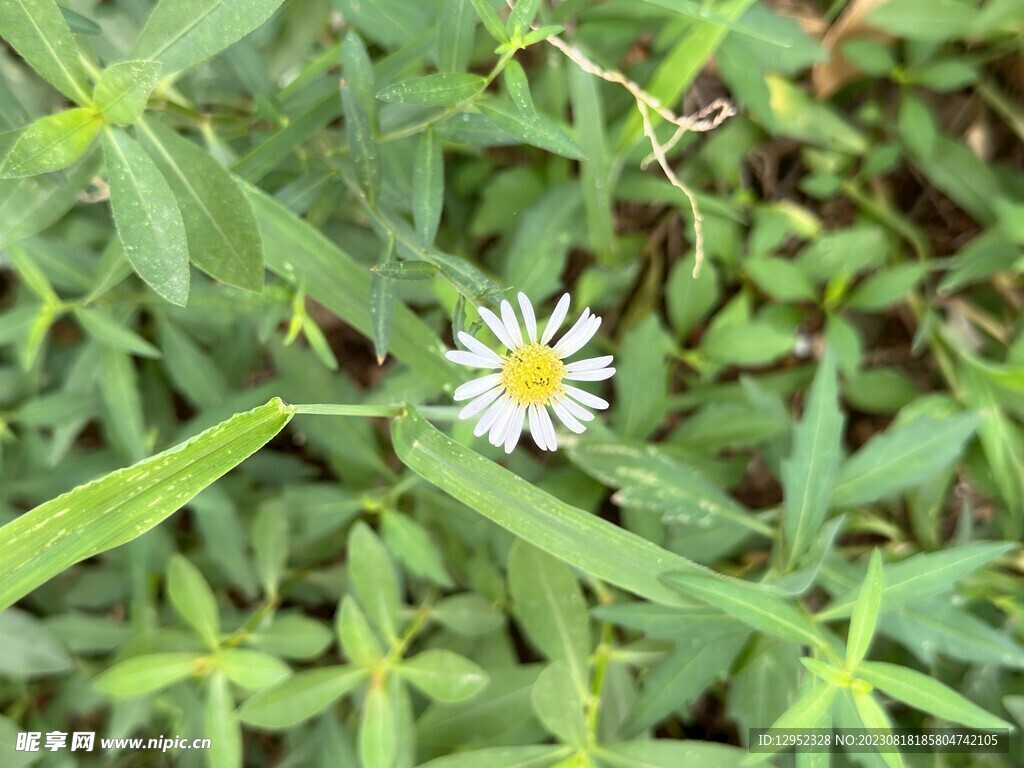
0,0,89,104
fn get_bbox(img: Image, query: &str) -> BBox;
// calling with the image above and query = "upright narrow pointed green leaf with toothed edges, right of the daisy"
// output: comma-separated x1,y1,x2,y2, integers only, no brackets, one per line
782,351,844,569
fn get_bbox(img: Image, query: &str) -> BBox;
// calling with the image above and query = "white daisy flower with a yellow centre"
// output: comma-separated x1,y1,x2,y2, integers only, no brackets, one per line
444,293,615,454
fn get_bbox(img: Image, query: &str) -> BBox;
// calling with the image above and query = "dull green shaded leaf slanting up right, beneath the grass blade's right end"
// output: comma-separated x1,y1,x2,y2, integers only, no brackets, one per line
622,632,749,734
